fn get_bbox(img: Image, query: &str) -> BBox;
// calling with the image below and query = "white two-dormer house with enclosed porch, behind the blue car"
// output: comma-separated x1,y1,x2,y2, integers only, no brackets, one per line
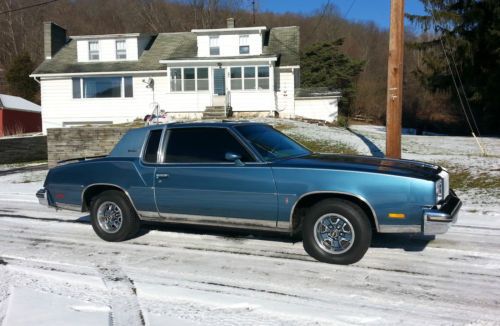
31,18,336,132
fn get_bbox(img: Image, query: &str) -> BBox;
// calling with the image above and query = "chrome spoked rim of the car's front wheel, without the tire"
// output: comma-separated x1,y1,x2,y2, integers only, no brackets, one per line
314,213,354,255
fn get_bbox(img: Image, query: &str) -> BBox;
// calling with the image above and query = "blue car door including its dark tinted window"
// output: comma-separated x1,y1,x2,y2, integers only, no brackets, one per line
155,127,277,227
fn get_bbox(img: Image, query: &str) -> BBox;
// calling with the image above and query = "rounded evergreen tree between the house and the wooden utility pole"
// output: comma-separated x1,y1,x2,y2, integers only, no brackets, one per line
300,39,364,116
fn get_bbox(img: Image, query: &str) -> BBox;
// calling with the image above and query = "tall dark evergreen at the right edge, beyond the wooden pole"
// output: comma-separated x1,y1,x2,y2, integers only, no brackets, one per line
407,0,500,133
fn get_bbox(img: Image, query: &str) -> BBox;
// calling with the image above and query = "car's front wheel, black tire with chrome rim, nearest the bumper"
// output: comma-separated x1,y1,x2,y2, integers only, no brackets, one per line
302,199,372,265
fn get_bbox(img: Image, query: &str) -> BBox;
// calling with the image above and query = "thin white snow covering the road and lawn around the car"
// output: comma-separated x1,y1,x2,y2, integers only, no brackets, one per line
0,121,500,326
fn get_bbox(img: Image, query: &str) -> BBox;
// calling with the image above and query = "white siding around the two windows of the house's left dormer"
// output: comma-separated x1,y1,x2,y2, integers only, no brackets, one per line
76,37,142,62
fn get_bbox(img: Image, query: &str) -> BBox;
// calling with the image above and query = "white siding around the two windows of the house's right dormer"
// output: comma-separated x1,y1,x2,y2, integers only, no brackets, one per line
197,31,262,57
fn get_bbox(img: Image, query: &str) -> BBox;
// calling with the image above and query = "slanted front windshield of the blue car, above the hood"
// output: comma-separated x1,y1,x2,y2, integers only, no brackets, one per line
235,125,311,162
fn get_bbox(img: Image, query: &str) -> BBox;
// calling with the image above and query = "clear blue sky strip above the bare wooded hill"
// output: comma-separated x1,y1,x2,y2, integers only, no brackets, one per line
258,0,424,28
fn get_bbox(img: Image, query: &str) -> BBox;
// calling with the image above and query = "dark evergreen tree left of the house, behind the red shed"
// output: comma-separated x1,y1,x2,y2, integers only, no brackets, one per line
5,53,39,102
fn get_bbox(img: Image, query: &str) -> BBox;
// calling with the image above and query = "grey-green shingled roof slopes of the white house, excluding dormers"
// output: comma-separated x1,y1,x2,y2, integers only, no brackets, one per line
32,26,299,76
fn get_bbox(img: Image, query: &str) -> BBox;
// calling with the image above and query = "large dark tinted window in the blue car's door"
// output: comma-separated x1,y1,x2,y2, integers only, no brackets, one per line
164,128,255,163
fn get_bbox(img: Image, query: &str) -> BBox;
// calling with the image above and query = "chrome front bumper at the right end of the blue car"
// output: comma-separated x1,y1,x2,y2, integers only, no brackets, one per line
422,189,462,235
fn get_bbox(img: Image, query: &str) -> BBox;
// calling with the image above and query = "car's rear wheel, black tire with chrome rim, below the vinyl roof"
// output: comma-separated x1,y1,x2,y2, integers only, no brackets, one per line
90,190,141,242
